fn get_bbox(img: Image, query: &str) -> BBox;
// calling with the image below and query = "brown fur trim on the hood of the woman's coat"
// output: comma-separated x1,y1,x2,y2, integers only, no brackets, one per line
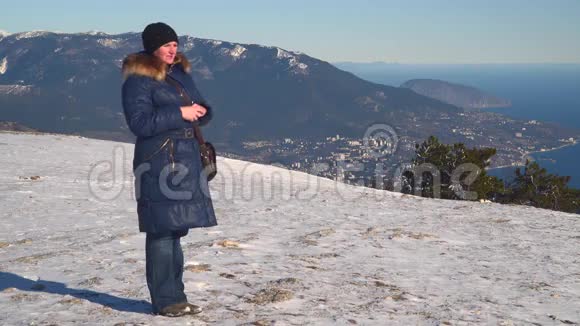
123,52,191,81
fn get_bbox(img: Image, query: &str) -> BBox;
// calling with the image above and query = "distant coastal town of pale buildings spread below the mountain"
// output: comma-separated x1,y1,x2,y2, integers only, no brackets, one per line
224,112,577,186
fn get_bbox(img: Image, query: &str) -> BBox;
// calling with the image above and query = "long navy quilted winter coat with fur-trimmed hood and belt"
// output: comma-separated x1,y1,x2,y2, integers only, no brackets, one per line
122,52,217,233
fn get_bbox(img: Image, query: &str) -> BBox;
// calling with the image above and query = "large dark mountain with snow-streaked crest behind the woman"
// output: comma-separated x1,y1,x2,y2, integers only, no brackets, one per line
0,31,460,142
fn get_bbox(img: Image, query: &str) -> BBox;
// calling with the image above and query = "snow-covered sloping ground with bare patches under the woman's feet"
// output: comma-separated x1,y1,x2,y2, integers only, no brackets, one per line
0,133,580,325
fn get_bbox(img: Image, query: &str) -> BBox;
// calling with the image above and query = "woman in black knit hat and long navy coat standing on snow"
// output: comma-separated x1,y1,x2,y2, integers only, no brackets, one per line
122,23,217,317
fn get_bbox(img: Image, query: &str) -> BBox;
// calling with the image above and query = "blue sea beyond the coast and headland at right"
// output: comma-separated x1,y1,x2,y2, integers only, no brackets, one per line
336,63,580,189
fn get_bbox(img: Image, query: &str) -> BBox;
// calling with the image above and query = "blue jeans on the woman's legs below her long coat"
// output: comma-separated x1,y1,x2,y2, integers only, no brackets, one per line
145,230,187,314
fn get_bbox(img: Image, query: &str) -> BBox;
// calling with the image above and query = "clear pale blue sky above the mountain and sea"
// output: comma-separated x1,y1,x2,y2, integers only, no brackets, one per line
0,0,580,63
